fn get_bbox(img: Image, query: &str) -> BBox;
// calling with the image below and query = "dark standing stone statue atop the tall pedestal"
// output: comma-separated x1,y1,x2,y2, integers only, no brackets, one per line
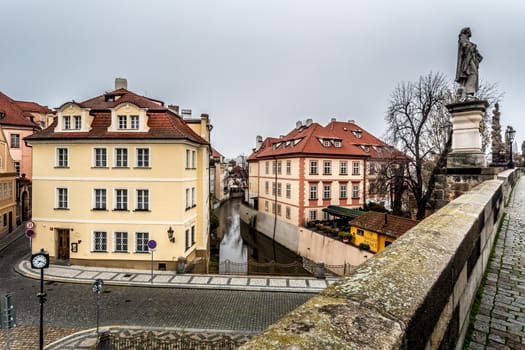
456,27,483,101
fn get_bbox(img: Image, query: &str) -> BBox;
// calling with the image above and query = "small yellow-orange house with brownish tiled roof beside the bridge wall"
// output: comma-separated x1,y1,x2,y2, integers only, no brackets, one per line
349,211,418,253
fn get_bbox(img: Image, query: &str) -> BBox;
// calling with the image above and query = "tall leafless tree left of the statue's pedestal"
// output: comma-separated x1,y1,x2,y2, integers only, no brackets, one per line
385,73,453,220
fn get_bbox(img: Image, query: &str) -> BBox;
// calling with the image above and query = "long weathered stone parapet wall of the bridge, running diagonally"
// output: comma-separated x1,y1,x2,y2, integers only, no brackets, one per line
241,171,519,349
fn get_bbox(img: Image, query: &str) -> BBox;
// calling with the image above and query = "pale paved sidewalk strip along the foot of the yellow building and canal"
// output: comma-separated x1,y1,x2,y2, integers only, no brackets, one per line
15,258,337,293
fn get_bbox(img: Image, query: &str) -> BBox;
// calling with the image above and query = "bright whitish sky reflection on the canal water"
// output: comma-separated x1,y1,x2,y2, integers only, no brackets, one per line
219,202,248,273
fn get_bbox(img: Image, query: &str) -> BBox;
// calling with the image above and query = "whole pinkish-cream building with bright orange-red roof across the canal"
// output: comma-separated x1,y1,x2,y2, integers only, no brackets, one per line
247,119,399,226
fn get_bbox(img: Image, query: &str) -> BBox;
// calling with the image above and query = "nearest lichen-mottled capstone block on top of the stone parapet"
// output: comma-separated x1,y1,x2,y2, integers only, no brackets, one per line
239,296,403,350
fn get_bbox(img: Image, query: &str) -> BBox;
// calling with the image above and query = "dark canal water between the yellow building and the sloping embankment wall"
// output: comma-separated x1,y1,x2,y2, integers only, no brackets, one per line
210,198,309,275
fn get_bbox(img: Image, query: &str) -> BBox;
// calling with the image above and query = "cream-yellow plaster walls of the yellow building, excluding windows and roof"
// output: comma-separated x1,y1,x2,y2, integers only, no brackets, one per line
33,139,208,266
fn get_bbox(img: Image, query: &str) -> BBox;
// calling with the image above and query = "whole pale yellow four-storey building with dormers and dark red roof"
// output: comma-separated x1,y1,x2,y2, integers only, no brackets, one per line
25,79,211,270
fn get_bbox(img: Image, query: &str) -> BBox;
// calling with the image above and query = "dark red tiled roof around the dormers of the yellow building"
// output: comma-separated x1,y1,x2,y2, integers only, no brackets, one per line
26,89,208,144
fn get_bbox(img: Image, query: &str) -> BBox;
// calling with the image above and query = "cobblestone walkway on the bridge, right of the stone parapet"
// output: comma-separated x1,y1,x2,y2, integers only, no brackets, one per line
465,178,525,350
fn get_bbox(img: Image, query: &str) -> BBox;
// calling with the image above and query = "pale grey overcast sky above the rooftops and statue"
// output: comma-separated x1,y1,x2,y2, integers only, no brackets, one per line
0,0,525,157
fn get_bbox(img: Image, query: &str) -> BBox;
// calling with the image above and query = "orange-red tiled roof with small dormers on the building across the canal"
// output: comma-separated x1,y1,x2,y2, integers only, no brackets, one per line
248,121,403,160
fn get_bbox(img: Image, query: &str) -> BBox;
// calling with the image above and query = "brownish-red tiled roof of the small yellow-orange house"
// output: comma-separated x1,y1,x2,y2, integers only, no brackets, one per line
349,211,419,238
